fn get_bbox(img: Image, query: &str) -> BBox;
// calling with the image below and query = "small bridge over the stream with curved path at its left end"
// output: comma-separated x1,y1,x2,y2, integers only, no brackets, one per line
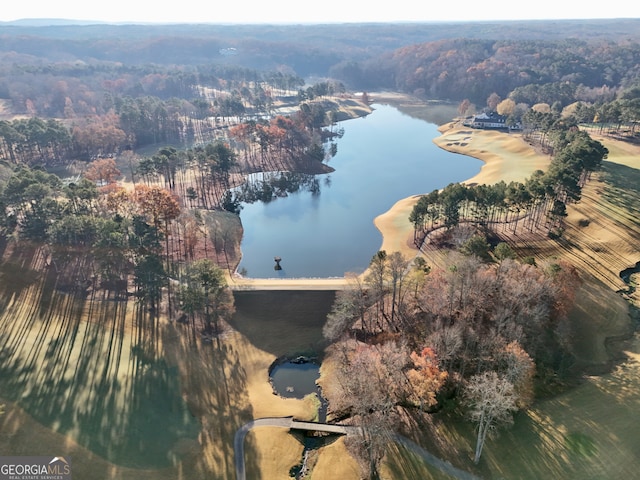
233,417,362,480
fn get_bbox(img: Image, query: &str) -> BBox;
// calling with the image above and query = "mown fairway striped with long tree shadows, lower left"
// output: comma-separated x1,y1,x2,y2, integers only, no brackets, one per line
0,260,201,468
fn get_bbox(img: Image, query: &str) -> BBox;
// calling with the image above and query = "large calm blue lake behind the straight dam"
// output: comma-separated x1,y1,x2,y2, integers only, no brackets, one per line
239,105,481,278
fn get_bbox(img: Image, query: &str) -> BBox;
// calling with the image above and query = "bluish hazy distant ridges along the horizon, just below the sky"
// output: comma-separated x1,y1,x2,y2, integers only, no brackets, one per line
0,19,640,76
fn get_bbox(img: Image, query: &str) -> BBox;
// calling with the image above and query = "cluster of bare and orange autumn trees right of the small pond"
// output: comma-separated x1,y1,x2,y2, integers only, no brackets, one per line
323,247,580,478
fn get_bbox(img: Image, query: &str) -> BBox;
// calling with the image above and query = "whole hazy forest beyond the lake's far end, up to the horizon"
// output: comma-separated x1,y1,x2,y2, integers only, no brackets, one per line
0,20,640,152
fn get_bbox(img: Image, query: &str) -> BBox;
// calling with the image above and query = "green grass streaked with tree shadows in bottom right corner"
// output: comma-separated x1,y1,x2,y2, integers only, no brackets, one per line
470,360,640,480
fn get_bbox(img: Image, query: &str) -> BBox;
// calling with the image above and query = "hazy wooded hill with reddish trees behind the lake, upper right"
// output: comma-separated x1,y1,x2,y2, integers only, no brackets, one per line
331,37,640,105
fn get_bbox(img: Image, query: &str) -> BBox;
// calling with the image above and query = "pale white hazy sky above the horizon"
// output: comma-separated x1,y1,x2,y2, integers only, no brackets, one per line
0,0,640,23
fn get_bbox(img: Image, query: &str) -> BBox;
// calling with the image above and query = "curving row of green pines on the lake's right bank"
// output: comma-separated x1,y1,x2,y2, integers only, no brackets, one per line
409,125,608,247
